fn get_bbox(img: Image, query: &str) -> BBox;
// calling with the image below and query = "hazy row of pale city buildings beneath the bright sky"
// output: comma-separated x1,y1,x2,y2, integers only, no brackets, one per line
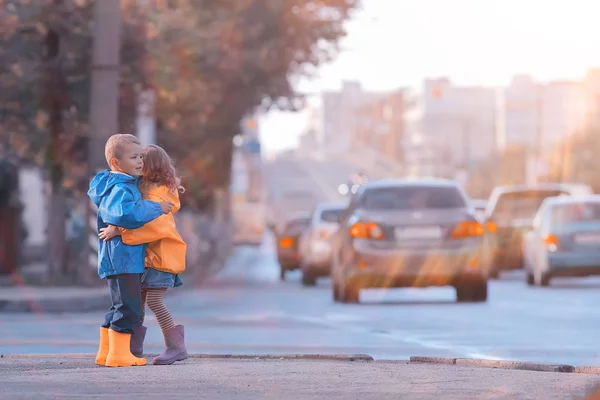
314,69,600,178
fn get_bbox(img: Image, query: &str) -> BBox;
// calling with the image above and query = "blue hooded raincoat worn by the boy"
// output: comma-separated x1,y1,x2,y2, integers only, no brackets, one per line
88,170,163,279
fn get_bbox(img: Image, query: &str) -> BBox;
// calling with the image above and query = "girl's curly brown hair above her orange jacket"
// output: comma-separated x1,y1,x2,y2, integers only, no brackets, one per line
141,144,185,193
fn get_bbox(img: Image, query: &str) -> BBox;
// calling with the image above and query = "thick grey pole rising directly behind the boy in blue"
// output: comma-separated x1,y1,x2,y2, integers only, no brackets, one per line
85,0,121,280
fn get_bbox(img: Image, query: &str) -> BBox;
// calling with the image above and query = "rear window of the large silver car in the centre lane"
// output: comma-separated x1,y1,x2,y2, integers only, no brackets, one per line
361,185,466,210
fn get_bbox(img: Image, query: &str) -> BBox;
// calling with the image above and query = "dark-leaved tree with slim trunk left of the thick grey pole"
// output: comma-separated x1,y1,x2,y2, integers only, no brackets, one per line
0,0,145,282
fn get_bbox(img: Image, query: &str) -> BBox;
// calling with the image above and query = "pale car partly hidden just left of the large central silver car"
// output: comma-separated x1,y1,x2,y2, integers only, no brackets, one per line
300,204,347,286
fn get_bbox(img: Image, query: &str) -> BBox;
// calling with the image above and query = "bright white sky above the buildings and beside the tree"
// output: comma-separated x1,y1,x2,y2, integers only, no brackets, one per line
260,0,600,153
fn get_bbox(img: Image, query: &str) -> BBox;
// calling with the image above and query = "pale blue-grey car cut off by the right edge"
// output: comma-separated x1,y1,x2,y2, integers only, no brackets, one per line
523,195,600,286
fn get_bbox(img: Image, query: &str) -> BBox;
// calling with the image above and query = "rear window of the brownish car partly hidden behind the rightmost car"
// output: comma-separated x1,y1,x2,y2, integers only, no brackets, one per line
492,190,568,220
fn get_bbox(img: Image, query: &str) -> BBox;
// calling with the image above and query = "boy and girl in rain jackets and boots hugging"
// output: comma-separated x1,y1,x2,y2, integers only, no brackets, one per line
88,134,188,367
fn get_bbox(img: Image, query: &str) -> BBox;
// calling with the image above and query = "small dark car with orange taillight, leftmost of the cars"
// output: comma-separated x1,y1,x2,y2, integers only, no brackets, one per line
276,214,310,280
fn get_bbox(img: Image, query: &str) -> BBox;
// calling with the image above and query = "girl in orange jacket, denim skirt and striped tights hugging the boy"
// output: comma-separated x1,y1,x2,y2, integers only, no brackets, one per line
100,145,188,365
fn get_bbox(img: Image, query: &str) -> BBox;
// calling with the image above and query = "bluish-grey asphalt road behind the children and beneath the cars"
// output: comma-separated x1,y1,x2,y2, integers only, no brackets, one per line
0,156,600,365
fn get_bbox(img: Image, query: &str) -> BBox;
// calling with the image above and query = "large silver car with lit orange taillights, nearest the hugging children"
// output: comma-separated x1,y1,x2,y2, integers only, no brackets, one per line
331,179,488,302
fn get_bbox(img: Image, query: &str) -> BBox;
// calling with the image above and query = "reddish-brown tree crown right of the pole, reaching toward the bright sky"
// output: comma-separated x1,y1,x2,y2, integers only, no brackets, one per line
143,0,357,202
